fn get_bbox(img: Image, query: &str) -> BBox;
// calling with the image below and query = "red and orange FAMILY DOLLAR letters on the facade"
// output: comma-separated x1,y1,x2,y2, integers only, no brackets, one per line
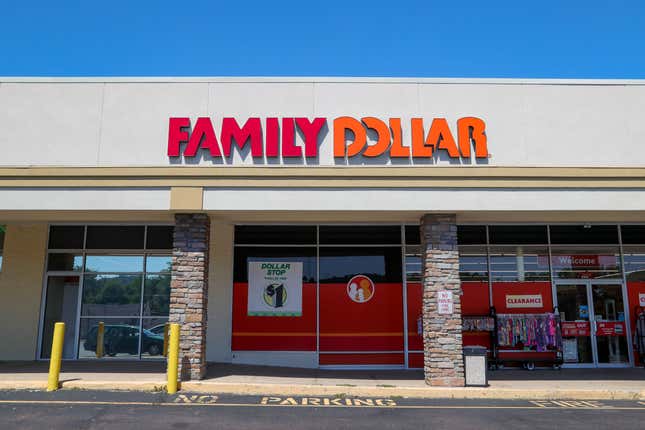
168,116,489,159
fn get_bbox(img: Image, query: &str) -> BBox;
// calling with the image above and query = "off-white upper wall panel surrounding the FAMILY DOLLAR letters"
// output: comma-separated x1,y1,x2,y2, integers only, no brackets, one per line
0,77,645,167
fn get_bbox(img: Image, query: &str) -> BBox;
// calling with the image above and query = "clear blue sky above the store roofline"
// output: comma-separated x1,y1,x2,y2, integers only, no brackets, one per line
0,0,645,78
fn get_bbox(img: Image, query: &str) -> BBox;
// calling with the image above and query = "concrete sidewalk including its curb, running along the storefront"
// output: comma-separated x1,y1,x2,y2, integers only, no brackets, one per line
0,361,645,400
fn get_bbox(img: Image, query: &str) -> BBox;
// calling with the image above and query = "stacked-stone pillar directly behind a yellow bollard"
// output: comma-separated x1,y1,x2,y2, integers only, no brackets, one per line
170,214,210,381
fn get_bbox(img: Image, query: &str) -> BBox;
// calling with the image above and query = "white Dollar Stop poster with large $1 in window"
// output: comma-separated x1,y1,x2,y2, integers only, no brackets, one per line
247,261,302,317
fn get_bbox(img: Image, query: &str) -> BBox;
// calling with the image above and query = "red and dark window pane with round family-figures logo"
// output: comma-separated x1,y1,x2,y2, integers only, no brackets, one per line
319,242,406,365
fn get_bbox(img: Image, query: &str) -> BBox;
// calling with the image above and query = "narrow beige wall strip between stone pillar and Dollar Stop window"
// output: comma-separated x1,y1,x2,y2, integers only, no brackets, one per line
206,219,233,363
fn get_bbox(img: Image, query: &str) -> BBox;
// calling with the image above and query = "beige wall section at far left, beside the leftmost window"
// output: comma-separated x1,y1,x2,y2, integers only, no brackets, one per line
0,223,47,360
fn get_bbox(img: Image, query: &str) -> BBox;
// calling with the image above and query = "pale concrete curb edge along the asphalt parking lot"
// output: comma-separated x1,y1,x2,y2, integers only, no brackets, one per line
0,380,645,400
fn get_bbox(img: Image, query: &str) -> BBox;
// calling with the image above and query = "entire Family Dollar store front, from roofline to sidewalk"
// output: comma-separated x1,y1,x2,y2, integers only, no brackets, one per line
0,78,645,385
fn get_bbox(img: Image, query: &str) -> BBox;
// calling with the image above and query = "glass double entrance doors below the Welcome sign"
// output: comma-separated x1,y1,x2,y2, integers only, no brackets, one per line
556,280,629,367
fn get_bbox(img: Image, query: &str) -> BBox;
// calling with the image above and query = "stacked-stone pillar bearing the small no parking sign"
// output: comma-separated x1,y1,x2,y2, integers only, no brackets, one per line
421,214,464,387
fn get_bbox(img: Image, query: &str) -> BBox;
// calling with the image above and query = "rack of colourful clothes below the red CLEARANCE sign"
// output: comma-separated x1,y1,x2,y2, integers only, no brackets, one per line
491,308,563,370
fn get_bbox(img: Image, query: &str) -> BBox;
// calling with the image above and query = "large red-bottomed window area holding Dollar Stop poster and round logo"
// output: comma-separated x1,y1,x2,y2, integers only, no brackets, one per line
232,225,406,365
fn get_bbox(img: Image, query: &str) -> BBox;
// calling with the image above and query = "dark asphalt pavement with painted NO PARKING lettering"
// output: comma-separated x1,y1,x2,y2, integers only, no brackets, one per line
0,390,645,430
